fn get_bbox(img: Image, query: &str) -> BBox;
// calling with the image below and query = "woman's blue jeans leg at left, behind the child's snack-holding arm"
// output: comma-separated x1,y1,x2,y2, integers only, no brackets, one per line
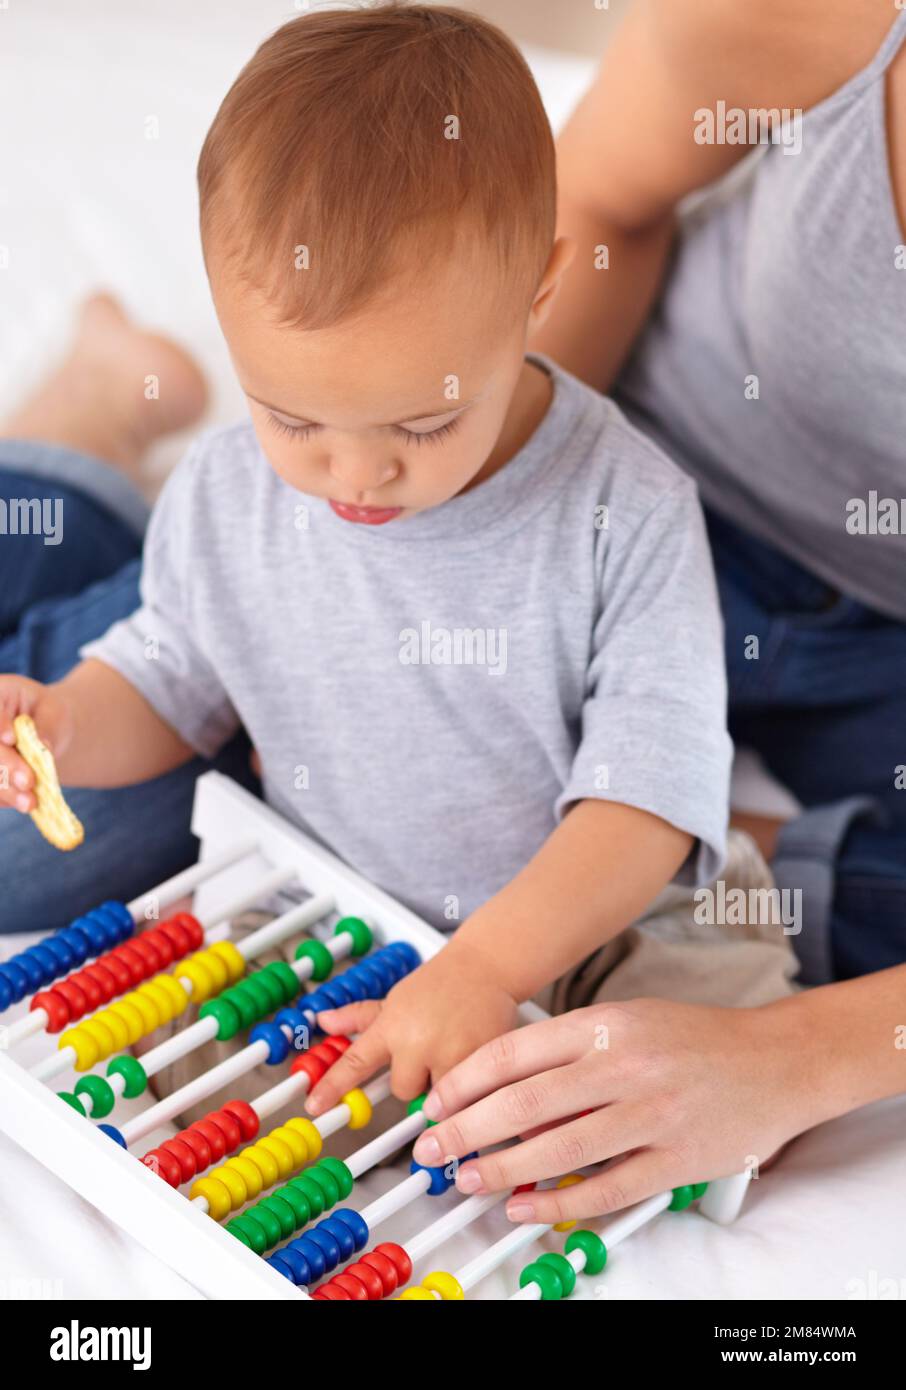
0,441,258,933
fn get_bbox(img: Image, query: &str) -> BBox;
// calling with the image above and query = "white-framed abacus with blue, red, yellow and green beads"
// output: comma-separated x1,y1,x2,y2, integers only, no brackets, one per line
0,771,745,1301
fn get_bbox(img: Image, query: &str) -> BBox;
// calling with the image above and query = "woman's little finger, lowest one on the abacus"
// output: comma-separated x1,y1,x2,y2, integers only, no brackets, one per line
506,1148,670,1226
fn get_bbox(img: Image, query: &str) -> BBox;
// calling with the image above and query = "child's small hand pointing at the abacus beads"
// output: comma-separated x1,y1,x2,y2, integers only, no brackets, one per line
306,942,517,1115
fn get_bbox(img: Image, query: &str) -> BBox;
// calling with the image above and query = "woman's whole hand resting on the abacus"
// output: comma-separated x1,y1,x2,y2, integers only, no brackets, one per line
414,999,824,1223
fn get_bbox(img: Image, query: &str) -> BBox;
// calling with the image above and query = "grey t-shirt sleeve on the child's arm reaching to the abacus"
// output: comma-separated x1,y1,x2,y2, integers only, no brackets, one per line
554,478,732,884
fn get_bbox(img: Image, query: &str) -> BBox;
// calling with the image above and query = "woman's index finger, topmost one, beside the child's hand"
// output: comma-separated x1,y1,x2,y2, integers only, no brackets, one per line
425,1009,593,1128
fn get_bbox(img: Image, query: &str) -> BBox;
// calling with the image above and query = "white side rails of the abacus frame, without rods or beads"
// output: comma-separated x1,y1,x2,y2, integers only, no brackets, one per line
0,771,746,1300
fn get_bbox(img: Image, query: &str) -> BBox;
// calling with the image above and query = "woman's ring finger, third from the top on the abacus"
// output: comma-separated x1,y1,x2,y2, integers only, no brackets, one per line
447,1102,652,1194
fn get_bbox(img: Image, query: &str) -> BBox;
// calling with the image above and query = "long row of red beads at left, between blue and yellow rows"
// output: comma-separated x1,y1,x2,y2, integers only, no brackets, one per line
31,912,204,1033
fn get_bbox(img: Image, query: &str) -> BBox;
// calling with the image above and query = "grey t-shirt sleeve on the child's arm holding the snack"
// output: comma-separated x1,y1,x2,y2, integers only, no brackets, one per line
81,443,239,758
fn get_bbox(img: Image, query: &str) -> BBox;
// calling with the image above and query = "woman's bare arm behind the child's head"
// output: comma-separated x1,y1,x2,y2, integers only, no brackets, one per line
532,0,872,391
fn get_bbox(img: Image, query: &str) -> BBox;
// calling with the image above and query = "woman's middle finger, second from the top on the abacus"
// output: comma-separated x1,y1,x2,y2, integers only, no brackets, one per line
413,1050,608,1162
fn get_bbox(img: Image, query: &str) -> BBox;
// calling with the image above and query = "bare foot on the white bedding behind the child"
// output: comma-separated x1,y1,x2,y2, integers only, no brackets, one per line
3,295,207,473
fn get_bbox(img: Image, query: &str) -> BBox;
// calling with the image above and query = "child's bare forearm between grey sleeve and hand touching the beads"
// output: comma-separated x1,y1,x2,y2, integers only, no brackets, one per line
447,799,693,1002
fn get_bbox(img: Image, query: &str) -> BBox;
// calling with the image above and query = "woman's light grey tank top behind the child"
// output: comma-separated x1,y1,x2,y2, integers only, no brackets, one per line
614,11,906,620
